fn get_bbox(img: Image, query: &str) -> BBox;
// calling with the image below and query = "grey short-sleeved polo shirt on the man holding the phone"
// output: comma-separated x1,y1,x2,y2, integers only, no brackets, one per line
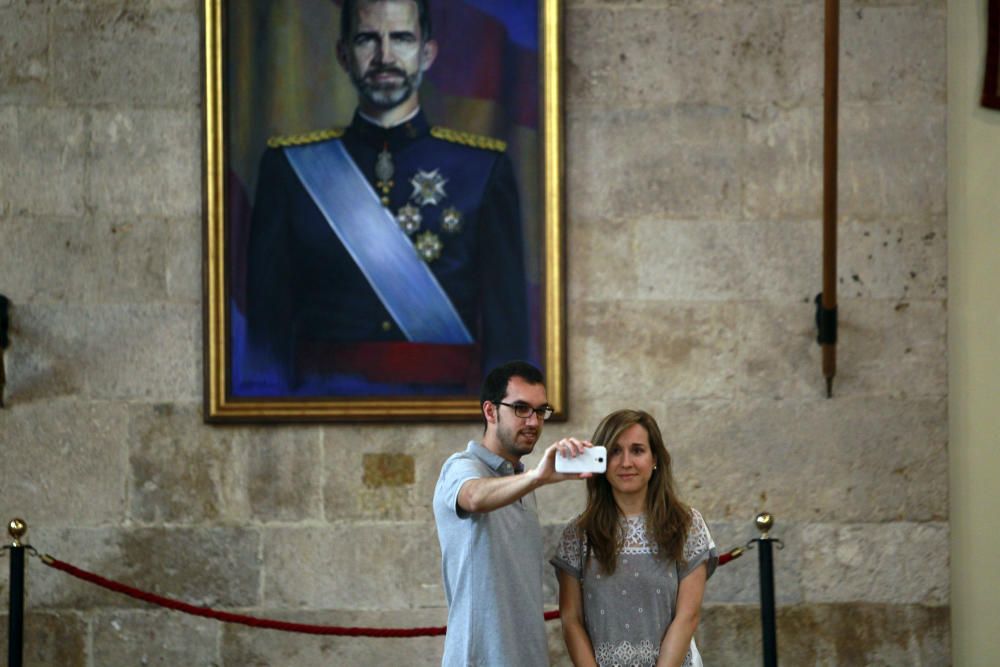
434,441,549,667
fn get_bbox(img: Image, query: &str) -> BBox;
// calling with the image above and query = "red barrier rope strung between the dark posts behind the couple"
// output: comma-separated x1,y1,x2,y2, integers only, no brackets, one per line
41,549,743,637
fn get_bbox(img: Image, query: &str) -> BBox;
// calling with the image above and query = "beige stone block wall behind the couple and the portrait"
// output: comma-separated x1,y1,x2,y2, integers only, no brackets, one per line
0,0,950,667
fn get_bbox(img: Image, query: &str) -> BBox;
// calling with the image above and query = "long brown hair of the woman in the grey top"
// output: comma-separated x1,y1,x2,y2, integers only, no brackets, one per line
577,410,691,574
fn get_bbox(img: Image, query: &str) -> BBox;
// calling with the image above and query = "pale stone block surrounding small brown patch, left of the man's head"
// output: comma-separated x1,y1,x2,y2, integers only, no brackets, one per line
323,424,472,524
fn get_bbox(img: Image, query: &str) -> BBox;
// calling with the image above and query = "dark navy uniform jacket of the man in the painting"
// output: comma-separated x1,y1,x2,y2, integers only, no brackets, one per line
247,113,530,394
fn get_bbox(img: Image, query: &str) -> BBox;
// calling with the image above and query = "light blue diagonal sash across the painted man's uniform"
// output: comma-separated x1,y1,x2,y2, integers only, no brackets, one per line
284,140,473,344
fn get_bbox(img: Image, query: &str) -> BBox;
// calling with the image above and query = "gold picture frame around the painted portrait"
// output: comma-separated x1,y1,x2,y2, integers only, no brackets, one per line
203,0,567,422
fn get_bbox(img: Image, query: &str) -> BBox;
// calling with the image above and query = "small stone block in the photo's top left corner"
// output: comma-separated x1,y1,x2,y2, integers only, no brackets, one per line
0,2,49,104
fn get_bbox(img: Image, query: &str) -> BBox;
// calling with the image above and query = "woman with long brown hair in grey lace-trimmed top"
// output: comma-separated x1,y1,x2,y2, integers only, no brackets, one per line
551,410,718,667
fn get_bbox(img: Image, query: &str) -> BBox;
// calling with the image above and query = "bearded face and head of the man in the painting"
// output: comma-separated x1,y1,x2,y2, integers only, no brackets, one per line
338,0,437,111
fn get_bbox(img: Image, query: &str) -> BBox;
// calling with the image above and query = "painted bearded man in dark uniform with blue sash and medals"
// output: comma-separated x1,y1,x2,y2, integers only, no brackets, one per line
247,0,529,395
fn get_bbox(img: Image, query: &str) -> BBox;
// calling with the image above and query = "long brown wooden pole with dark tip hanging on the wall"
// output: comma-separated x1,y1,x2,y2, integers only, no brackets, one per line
816,0,840,398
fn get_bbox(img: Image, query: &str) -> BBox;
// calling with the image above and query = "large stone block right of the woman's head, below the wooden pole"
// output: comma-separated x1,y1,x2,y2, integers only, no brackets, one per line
653,397,948,524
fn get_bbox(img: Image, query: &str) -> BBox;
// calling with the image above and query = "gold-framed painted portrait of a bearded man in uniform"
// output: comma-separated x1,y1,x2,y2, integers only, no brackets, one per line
204,0,566,422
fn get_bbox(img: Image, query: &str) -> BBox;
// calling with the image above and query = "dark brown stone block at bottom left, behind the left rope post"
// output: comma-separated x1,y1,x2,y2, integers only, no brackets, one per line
0,612,91,667
